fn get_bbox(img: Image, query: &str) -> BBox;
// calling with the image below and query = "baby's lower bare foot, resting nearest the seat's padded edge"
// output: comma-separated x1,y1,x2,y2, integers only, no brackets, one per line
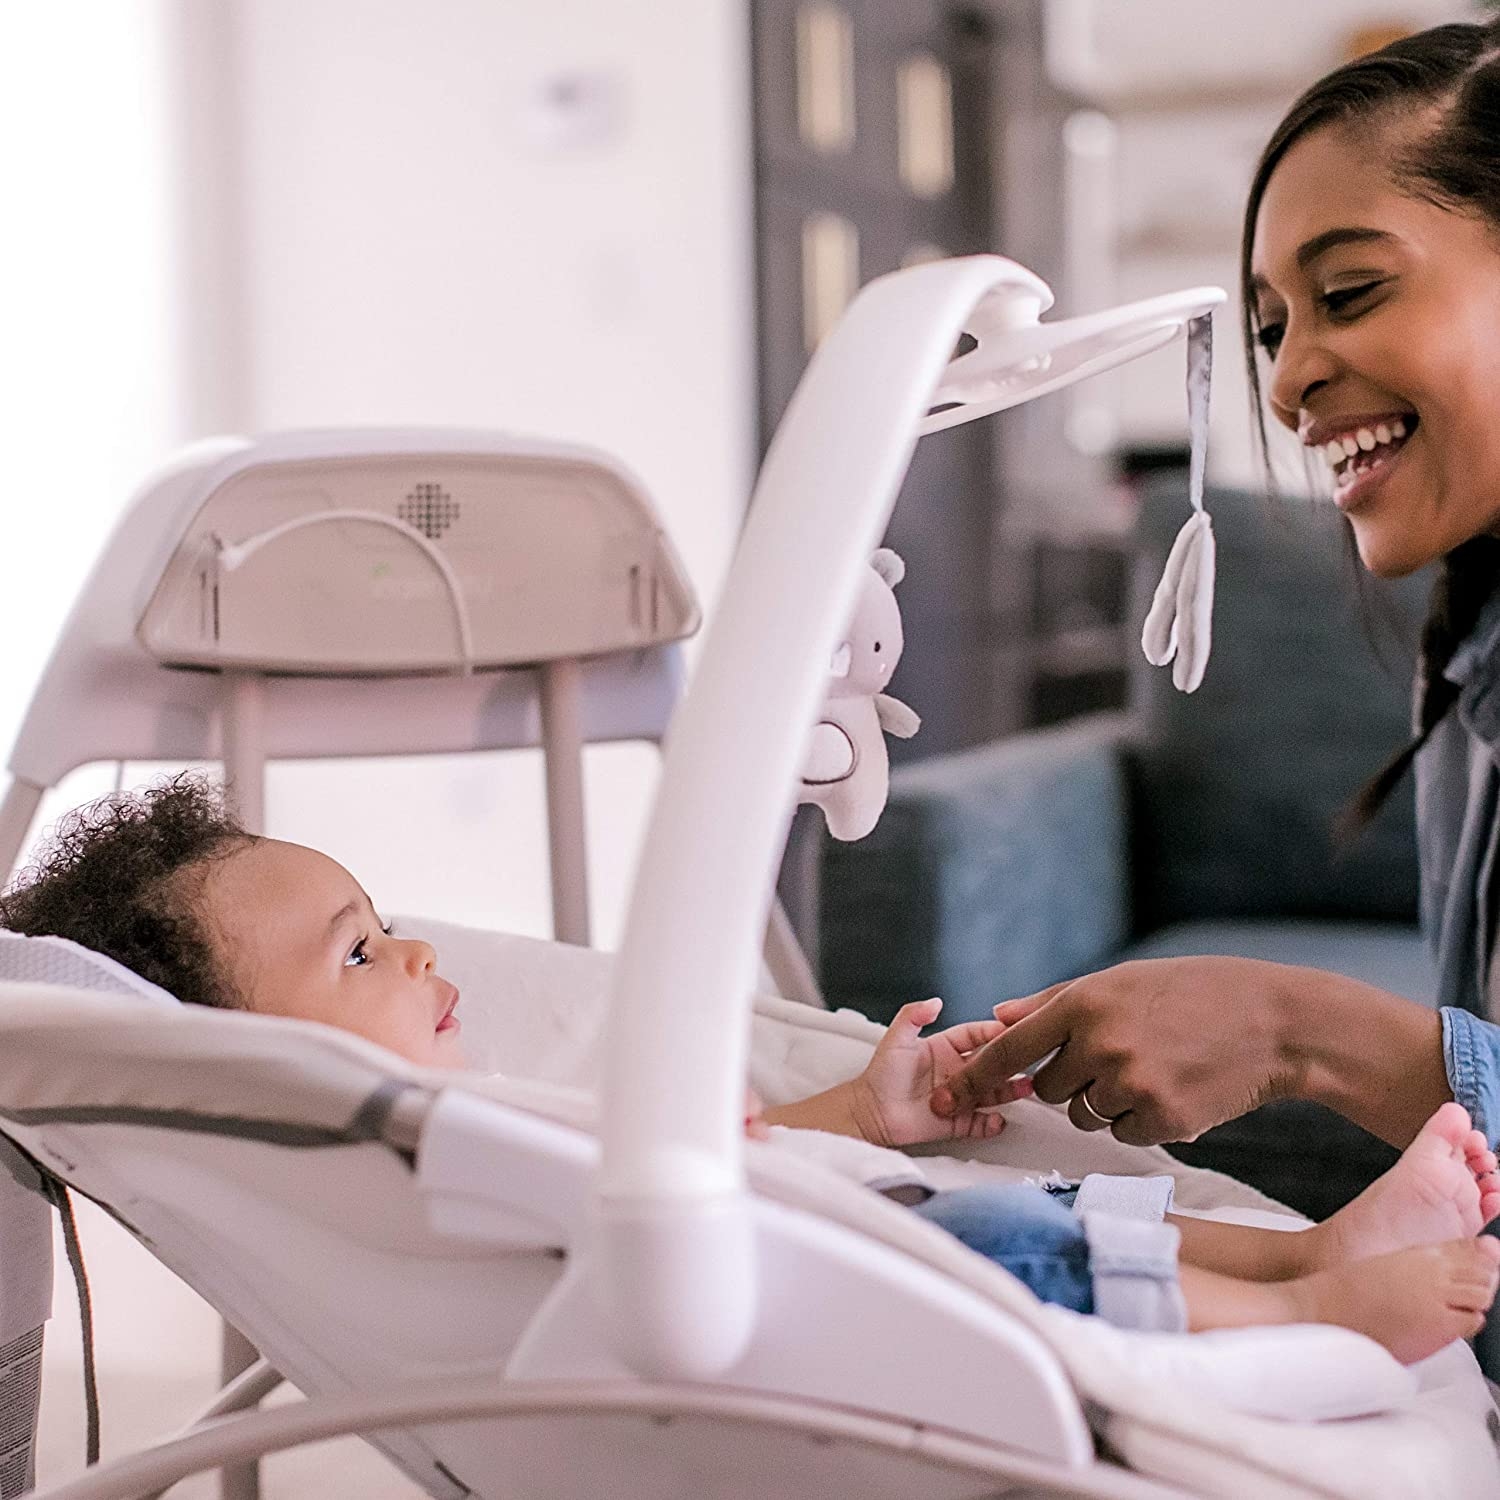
1284,1236,1500,1365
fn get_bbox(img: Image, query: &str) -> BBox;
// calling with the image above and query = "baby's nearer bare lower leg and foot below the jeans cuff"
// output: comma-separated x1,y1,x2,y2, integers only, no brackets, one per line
1182,1236,1500,1365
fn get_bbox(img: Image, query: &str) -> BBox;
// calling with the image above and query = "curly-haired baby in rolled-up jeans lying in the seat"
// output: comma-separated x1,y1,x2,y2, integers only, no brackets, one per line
11,776,1500,1362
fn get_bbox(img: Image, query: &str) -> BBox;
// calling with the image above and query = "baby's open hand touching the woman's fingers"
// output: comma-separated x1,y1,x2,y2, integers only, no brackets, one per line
852,999,1031,1146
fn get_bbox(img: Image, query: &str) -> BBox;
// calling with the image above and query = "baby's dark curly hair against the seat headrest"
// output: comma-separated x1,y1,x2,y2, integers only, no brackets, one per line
0,771,255,1008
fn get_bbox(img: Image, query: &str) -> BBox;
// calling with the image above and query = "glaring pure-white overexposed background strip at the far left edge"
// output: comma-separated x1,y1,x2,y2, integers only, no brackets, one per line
0,0,182,840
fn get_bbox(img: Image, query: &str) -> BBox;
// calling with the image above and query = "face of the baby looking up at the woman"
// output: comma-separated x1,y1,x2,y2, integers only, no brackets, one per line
201,839,464,1068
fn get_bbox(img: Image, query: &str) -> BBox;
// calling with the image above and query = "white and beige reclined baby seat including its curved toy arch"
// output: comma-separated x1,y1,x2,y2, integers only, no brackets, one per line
0,257,1500,1500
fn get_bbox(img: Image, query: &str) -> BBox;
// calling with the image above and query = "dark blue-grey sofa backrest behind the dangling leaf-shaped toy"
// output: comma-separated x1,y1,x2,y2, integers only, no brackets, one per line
1131,477,1431,930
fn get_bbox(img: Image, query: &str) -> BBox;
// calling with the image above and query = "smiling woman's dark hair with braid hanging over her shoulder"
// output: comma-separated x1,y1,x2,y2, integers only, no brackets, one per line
1239,21,1500,834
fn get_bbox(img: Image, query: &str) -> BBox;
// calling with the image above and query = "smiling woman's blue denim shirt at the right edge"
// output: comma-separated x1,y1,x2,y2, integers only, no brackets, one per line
1416,591,1500,1142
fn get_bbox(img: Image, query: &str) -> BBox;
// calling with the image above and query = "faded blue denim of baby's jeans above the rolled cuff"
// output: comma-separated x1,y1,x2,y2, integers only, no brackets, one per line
912,1184,1094,1313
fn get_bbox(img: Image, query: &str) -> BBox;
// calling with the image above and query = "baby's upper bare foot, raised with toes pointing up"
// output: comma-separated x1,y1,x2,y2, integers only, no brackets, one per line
1302,1104,1500,1269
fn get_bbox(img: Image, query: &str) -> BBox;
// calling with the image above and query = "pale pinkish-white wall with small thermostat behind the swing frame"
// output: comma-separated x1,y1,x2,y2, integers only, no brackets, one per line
178,0,755,942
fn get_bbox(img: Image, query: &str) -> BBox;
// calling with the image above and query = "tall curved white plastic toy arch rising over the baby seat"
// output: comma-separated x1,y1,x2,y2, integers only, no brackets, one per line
591,255,1224,1379
